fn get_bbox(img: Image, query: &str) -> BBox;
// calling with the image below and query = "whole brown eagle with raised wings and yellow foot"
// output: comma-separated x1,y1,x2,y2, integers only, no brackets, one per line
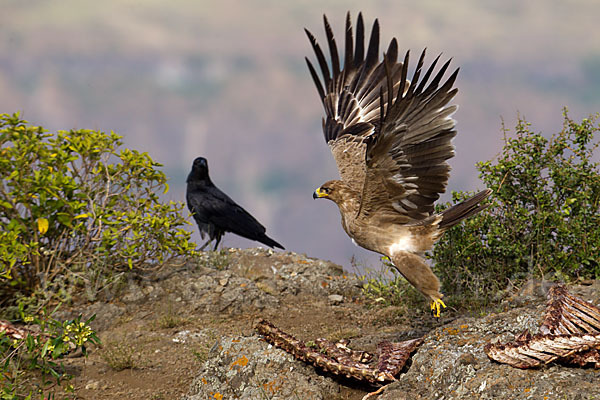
306,13,491,315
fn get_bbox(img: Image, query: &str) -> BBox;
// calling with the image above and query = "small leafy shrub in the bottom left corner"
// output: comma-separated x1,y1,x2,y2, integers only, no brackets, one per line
0,309,100,399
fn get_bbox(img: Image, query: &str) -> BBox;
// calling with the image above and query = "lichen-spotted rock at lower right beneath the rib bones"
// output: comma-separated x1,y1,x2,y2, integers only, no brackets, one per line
379,288,600,400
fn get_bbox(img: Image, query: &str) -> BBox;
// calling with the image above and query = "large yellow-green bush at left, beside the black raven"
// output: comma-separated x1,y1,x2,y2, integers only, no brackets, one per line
0,114,194,302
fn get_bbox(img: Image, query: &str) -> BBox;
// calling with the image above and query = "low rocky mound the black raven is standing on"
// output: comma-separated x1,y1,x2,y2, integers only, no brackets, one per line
57,248,359,330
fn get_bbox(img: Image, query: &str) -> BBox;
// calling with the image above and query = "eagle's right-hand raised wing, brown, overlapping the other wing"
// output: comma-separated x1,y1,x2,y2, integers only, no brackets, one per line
359,51,458,224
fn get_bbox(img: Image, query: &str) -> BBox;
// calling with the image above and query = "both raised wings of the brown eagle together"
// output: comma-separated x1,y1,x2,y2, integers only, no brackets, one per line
306,14,458,224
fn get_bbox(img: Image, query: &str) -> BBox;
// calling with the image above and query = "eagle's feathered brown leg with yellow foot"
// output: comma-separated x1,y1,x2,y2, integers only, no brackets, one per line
390,251,446,318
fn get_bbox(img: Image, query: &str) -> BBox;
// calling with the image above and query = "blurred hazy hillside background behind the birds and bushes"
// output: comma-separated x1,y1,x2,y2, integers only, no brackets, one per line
0,0,600,268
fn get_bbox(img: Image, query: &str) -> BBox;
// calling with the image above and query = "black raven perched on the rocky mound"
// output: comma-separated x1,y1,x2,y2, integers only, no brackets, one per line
185,157,283,250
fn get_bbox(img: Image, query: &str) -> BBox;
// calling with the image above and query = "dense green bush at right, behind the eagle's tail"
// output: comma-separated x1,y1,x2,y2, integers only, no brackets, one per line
431,110,600,305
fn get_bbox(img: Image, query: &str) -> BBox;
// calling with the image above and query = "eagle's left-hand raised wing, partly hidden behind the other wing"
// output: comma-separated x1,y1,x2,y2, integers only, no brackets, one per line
305,13,408,193
